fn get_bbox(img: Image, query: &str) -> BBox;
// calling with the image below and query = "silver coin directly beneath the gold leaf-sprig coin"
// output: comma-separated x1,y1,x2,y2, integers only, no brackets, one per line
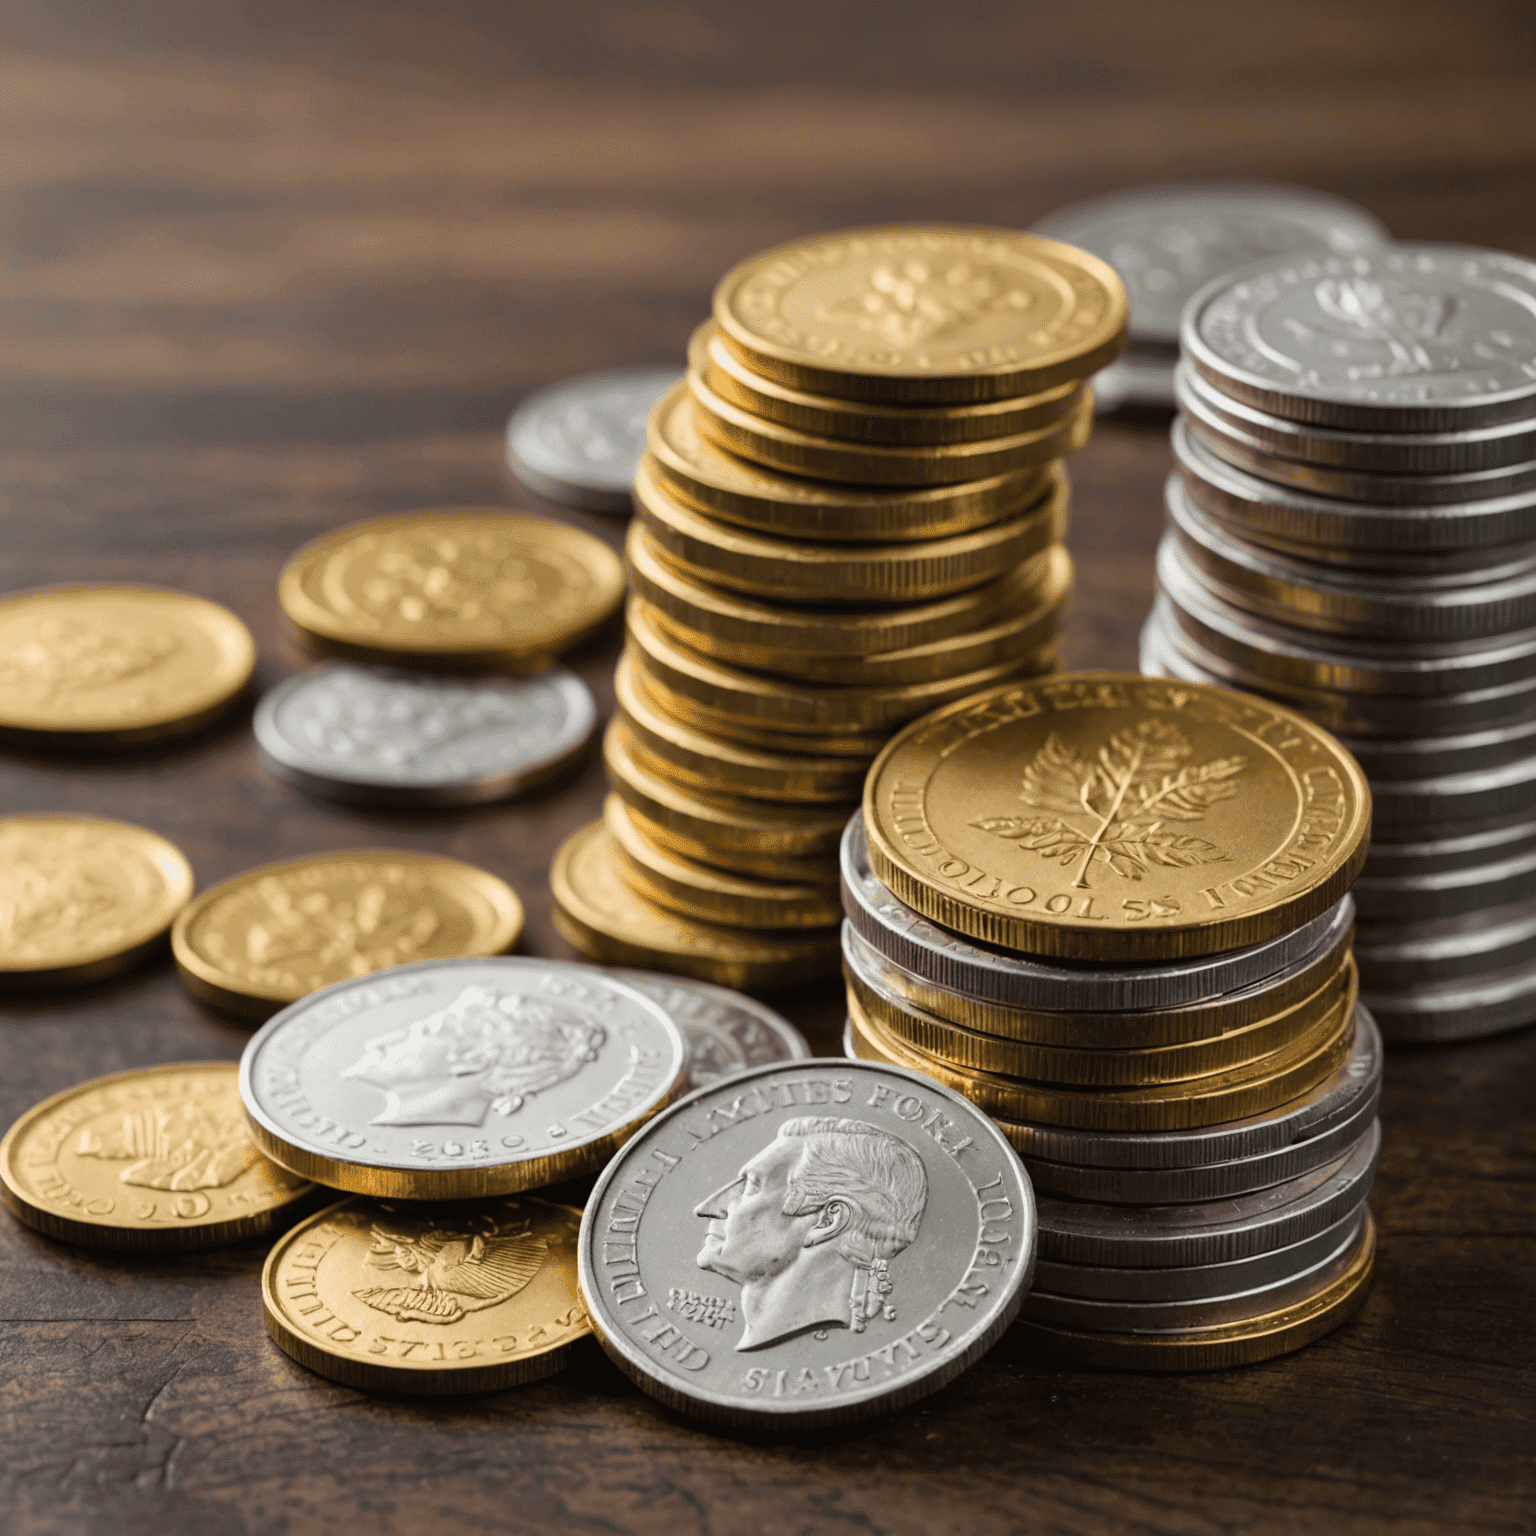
839,811,1353,1012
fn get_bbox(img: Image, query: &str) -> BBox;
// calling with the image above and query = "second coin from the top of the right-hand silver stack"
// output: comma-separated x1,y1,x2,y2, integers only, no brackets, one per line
1174,362,1536,475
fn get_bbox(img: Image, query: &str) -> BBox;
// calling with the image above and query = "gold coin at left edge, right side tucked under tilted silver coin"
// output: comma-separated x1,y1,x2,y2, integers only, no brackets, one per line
0,1061,315,1253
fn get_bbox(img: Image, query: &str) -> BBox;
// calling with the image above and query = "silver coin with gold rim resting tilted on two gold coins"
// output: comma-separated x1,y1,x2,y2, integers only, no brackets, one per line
240,957,688,1200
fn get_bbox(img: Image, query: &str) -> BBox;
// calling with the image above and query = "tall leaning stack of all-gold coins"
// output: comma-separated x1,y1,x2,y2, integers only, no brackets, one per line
553,226,1126,989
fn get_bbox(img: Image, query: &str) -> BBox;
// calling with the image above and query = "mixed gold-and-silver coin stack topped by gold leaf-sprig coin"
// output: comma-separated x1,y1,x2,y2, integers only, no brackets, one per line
842,674,1382,1370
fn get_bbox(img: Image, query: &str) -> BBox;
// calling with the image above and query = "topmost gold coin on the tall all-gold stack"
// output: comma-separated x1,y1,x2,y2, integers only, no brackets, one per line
714,224,1127,404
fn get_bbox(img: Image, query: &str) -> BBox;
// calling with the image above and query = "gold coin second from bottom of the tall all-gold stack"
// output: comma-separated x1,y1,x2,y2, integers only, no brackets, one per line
602,794,843,929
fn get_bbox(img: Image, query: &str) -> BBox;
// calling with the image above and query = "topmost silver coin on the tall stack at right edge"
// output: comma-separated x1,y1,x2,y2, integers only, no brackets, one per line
1180,244,1536,432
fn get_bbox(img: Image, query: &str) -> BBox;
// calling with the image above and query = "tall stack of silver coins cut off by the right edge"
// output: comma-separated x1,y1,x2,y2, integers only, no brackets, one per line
1141,246,1536,1040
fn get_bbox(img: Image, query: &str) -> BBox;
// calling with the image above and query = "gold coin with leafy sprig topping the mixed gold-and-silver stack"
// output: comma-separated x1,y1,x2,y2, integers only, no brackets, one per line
865,673,1370,963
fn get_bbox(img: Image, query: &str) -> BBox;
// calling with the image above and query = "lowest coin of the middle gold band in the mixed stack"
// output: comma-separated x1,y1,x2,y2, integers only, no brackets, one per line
848,960,1358,1130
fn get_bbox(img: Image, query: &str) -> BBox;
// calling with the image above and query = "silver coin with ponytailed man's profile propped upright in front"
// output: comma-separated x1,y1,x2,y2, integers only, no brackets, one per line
581,1060,1035,1428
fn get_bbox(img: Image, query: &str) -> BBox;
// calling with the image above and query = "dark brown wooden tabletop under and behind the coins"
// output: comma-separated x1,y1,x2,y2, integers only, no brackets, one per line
0,0,1536,1536
